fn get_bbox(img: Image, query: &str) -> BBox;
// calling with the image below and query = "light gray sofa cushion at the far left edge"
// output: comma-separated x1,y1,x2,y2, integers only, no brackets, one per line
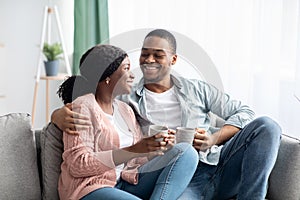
0,113,41,199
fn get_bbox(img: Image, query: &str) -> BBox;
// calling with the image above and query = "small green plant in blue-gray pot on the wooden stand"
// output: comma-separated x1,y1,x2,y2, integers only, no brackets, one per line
43,43,63,76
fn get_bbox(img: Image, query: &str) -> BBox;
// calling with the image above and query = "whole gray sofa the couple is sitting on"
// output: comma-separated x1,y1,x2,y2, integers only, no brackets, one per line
0,113,300,200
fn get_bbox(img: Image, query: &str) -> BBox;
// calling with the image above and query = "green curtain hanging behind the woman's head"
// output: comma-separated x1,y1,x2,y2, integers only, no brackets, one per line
72,0,109,74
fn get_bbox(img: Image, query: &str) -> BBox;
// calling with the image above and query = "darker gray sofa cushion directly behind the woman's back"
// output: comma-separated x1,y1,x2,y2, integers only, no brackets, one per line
40,123,63,200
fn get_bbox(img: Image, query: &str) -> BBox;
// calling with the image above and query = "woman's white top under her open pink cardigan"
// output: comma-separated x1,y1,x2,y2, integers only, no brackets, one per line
105,104,133,180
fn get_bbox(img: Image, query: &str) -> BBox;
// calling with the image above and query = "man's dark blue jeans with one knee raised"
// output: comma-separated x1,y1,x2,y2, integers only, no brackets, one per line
179,117,281,200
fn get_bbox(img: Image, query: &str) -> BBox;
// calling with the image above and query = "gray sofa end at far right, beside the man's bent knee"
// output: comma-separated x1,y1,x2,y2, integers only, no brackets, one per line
267,135,300,200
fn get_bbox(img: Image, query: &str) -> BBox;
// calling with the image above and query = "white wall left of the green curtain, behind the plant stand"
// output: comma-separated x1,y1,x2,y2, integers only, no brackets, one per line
0,0,73,128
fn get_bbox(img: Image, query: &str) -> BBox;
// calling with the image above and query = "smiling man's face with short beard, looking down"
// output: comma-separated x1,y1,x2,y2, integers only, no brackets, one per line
140,36,177,83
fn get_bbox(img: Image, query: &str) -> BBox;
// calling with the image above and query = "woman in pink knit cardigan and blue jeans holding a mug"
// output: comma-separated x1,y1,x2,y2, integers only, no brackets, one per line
58,45,198,200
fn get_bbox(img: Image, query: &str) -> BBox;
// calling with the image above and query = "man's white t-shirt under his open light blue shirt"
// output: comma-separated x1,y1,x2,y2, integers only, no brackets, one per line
145,87,181,129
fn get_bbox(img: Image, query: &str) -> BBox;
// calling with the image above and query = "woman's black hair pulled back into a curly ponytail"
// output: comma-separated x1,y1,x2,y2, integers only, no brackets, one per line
57,45,127,104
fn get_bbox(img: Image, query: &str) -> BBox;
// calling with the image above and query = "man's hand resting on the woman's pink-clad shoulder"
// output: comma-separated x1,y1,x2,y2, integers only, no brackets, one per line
51,103,91,134
